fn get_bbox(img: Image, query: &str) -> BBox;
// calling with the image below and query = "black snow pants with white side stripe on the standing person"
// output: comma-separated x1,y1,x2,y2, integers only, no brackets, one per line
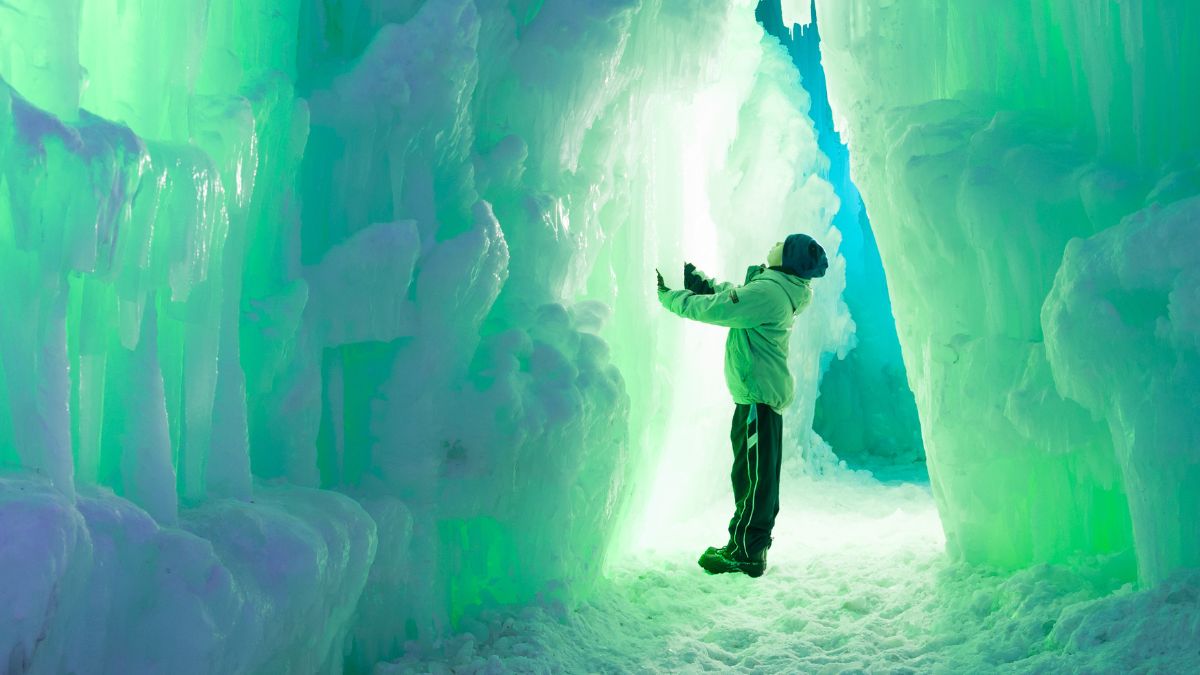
730,404,784,557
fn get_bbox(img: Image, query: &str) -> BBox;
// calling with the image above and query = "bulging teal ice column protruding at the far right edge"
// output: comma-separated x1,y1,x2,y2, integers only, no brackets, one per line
1042,197,1200,583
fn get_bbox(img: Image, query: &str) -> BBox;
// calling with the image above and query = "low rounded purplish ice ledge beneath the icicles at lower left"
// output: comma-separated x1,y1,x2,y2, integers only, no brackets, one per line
0,476,377,674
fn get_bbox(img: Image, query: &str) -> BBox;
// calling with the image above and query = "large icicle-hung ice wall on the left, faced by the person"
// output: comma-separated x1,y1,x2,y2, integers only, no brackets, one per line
0,0,850,673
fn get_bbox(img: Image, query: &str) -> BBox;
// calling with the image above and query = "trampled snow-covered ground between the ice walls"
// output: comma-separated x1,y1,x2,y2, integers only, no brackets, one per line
376,474,1200,675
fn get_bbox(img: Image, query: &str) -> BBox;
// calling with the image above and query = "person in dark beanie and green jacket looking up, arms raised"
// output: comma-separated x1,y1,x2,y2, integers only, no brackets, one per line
655,234,829,577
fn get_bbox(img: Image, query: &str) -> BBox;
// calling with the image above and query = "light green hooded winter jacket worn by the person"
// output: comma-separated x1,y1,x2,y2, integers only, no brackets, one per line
659,265,812,412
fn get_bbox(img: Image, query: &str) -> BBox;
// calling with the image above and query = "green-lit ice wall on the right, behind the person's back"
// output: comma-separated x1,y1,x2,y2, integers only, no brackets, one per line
817,0,1200,584
